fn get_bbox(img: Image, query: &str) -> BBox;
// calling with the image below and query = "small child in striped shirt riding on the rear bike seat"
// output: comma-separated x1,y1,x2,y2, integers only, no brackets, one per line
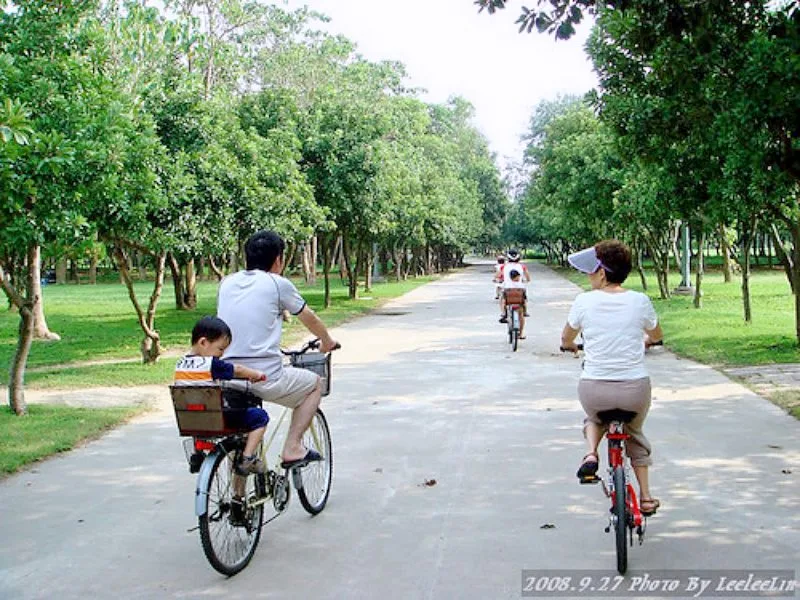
175,317,269,476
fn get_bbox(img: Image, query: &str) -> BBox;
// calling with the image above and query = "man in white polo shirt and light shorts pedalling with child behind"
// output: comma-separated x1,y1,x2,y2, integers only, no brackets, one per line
217,231,337,468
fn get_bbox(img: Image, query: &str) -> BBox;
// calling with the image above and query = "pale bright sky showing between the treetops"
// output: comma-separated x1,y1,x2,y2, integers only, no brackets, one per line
287,0,597,166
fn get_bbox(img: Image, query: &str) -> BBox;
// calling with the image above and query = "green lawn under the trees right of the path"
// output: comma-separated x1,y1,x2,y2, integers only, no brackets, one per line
557,269,800,365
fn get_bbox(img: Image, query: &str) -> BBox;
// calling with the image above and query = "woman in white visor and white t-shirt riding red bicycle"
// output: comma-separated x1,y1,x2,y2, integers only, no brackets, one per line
561,240,663,515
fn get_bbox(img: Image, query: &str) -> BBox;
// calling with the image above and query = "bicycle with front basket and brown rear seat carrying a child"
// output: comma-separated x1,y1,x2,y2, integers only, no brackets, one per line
170,340,339,576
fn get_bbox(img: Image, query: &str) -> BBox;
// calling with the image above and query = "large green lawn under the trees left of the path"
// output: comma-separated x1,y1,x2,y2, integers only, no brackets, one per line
0,277,432,388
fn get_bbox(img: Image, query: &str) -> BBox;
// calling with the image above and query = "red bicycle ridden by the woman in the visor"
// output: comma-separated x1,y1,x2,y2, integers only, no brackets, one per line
561,341,663,575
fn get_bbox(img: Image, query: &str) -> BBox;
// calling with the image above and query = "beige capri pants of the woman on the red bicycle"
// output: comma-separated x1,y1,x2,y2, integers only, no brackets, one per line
578,377,653,467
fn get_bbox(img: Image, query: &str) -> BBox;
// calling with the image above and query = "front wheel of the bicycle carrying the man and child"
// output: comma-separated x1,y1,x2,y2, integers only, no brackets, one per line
297,409,333,515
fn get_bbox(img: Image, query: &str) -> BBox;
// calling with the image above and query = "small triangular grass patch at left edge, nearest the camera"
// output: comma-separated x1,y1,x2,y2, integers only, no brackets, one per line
0,404,146,478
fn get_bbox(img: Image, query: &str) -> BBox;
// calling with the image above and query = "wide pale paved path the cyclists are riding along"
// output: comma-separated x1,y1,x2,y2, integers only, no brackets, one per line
0,265,800,600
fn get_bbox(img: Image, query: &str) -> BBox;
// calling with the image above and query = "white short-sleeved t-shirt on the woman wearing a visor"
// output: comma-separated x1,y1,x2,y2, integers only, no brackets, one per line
567,290,658,381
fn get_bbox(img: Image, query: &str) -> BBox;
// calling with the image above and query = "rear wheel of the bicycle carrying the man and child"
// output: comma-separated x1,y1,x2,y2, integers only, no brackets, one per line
200,450,266,576
